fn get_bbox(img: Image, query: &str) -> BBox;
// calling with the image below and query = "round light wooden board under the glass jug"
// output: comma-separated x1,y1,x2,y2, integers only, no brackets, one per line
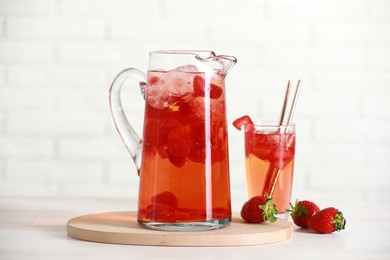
67,212,292,246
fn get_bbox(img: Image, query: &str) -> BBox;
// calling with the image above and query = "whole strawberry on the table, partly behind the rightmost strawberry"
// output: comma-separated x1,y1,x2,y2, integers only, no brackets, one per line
289,200,320,228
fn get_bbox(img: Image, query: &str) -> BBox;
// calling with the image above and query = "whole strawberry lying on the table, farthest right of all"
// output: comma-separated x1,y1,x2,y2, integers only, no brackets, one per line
307,207,346,234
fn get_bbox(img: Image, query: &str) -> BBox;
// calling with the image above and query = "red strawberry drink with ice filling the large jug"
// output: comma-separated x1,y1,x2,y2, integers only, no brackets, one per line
138,70,231,223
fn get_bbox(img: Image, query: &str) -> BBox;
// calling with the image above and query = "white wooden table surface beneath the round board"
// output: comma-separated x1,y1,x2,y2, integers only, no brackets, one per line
0,198,390,260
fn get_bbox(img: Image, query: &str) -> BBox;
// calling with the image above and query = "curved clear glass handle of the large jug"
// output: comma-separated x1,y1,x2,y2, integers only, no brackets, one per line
109,68,146,175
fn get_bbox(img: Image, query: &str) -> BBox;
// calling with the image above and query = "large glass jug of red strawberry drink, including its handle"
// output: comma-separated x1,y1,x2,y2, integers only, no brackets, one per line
109,51,237,231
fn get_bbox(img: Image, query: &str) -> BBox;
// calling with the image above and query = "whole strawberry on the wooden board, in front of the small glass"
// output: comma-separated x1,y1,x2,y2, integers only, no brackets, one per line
241,195,278,223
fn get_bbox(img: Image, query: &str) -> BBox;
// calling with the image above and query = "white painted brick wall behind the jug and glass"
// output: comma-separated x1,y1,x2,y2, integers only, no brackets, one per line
0,0,390,204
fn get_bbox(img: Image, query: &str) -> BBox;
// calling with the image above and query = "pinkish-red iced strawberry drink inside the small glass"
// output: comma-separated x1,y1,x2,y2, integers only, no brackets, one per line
245,126,295,213
